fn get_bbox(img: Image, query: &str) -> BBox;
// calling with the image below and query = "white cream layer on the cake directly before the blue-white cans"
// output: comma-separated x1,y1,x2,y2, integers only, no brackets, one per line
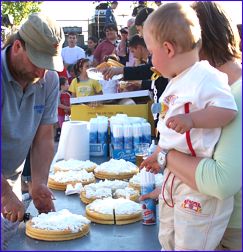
94,159,138,174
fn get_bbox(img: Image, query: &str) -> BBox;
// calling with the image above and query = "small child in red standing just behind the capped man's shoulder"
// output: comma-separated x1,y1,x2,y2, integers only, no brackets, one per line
58,77,71,128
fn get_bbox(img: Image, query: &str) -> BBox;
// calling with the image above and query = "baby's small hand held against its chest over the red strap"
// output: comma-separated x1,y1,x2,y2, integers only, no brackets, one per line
166,114,194,134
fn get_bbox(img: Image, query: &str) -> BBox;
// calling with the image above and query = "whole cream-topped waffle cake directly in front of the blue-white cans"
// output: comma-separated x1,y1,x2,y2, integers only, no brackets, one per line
94,159,139,180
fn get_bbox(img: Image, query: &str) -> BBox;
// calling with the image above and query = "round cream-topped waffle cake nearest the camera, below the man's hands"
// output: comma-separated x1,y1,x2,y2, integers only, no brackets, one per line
25,209,90,241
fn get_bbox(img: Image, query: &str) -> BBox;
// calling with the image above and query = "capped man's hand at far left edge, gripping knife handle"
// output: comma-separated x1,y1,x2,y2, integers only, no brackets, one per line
1,190,25,222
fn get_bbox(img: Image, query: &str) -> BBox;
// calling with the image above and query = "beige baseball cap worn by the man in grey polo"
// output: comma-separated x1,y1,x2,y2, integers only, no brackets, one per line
19,13,65,72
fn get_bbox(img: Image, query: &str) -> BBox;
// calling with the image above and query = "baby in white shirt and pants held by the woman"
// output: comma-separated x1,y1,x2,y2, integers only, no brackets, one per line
141,3,237,251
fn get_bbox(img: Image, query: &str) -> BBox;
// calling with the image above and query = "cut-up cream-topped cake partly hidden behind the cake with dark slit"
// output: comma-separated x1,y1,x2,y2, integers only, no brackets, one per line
80,180,139,204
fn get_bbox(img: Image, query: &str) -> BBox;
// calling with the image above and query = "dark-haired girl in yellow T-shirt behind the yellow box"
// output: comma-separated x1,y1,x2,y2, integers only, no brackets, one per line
69,59,103,97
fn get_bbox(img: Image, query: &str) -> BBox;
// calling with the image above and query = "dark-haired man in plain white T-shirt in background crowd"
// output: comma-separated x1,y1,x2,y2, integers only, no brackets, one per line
62,32,85,67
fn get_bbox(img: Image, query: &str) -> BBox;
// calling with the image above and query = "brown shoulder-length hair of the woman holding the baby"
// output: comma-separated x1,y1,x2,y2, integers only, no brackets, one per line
192,2,241,67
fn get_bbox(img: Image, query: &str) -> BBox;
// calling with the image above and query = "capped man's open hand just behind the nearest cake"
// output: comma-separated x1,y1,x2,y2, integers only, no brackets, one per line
32,184,55,213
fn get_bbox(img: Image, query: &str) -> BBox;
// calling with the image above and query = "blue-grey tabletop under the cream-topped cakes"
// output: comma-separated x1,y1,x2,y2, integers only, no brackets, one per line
8,158,161,251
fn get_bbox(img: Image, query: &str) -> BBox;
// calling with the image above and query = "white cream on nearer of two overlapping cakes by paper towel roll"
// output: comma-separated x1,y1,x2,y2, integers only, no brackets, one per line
49,170,94,183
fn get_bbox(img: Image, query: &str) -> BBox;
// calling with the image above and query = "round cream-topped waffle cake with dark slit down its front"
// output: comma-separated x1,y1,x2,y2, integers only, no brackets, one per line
86,198,142,225
